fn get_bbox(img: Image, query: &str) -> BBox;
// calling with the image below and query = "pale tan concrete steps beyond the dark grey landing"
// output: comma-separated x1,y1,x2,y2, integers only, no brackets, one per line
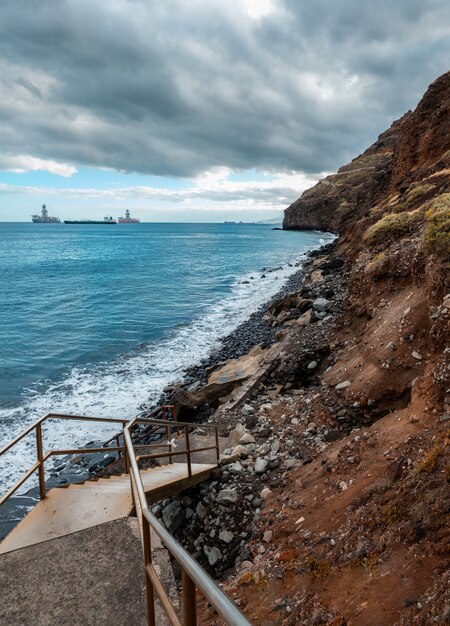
0,463,216,552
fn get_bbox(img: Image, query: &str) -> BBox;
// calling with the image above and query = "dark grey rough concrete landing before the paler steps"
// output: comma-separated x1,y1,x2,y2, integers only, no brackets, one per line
0,520,176,626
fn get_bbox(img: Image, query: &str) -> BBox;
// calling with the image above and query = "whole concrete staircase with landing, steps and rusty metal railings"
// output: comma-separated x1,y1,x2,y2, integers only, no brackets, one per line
0,406,250,626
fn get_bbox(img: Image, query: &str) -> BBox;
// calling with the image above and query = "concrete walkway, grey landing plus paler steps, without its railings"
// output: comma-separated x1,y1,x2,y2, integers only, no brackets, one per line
0,463,216,626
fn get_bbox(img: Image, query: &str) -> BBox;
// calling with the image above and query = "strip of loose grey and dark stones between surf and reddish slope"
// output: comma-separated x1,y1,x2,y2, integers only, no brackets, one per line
149,244,350,578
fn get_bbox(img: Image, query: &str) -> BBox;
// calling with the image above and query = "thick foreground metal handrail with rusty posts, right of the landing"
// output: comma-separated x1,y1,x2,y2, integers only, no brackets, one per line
124,418,250,626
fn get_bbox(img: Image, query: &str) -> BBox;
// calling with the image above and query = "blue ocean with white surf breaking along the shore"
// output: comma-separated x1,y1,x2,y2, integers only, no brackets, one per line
0,223,332,489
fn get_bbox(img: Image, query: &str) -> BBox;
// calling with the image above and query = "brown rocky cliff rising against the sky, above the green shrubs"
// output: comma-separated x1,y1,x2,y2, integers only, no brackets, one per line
283,72,450,240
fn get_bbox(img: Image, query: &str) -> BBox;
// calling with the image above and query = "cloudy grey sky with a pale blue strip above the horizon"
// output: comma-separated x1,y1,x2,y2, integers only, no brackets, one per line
0,0,450,222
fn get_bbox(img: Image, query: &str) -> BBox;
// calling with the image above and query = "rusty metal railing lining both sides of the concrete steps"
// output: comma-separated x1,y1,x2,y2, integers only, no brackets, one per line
0,407,251,626
